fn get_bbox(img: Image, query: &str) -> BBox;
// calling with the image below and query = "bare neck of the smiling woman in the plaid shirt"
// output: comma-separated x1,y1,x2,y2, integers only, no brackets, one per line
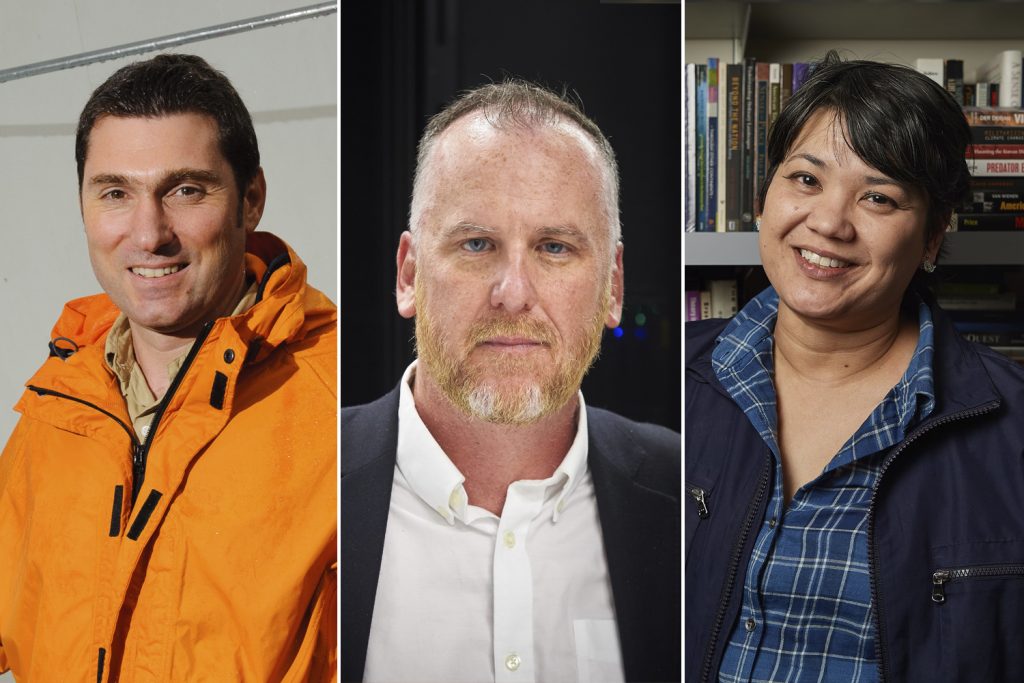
774,306,919,383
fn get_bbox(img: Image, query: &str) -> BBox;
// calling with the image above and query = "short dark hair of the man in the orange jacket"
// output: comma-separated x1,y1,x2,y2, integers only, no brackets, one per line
75,54,259,194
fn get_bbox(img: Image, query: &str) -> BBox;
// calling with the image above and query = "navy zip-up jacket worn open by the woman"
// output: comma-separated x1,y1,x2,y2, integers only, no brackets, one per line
684,294,1024,683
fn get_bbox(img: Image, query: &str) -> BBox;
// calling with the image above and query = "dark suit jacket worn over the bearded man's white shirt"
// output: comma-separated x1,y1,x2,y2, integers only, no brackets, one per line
339,388,682,681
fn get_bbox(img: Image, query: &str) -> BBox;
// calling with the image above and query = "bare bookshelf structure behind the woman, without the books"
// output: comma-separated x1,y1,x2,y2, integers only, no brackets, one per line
684,0,1024,270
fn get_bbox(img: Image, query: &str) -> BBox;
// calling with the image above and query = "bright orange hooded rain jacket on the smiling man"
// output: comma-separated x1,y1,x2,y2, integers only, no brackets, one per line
0,232,338,683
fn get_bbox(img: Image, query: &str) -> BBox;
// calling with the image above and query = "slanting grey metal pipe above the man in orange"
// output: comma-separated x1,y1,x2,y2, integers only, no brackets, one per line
0,0,338,83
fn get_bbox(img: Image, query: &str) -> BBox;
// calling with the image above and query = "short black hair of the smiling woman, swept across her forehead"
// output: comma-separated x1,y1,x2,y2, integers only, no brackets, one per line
758,50,971,242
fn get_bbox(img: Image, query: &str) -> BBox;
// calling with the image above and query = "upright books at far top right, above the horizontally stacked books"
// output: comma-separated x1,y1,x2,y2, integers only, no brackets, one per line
914,50,1024,106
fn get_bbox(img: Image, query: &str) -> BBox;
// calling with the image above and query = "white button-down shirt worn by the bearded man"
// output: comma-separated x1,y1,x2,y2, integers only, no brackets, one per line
368,362,624,683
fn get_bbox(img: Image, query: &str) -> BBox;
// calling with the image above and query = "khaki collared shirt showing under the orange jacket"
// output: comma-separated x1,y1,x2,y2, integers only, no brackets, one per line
103,281,259,443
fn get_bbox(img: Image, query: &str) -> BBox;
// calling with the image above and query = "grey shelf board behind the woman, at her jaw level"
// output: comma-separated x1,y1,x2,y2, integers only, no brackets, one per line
685,231,1024,266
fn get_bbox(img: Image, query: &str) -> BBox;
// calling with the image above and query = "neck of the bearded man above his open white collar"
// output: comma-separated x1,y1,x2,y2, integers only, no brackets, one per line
413,365,579,516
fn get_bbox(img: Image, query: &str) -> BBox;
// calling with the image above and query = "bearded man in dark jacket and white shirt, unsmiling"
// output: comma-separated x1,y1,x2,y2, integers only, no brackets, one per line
339,81,680,682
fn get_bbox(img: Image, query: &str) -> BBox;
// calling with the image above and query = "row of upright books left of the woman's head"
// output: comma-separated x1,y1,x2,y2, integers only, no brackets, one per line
685,58,811,232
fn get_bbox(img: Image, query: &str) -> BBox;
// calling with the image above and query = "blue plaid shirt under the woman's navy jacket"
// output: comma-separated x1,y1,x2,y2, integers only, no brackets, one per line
712,288,935,683
